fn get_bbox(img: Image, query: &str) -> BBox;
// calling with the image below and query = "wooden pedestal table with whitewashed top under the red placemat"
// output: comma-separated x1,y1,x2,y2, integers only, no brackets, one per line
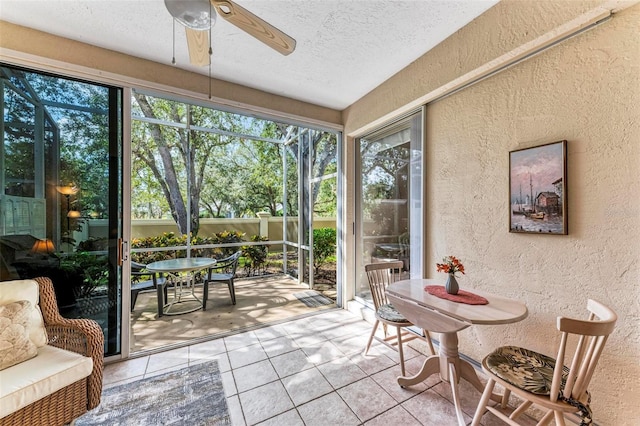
387,279,527,426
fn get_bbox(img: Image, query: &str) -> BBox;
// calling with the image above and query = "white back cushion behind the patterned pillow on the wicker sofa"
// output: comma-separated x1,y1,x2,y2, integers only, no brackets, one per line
0,280,47,347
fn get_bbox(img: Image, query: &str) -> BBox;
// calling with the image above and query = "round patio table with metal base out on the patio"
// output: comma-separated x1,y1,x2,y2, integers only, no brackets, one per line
147,257,216,315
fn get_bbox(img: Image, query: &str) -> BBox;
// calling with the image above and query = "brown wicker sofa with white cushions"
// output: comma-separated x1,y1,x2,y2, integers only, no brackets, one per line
0,278,104,426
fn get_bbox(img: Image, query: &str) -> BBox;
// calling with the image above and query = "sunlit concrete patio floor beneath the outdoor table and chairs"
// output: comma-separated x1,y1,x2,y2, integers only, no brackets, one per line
130,275,336,354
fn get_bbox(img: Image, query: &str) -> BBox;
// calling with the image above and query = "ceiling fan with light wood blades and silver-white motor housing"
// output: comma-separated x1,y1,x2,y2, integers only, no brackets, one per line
164,0,296,66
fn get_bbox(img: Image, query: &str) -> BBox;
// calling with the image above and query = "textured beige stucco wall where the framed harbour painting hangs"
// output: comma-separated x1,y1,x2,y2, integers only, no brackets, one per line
344,1,640,426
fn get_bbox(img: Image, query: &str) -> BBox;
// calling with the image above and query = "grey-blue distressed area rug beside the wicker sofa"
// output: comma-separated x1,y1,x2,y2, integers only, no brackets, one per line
75,361,231,426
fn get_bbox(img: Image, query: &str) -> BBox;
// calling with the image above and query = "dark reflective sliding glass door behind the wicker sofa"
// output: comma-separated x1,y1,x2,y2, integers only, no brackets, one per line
0,66,122,355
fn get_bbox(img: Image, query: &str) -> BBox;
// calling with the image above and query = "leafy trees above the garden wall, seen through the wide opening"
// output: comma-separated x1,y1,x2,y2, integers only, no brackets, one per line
132,92,337,235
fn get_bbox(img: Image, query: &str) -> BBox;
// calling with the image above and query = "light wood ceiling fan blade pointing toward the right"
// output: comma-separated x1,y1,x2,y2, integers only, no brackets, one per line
210,0,296,55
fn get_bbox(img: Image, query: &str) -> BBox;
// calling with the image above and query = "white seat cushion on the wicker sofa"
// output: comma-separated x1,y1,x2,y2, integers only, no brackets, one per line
0,345,93,418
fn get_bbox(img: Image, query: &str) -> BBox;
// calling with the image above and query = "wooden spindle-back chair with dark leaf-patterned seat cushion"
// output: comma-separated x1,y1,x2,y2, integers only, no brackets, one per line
471,299,618,426
